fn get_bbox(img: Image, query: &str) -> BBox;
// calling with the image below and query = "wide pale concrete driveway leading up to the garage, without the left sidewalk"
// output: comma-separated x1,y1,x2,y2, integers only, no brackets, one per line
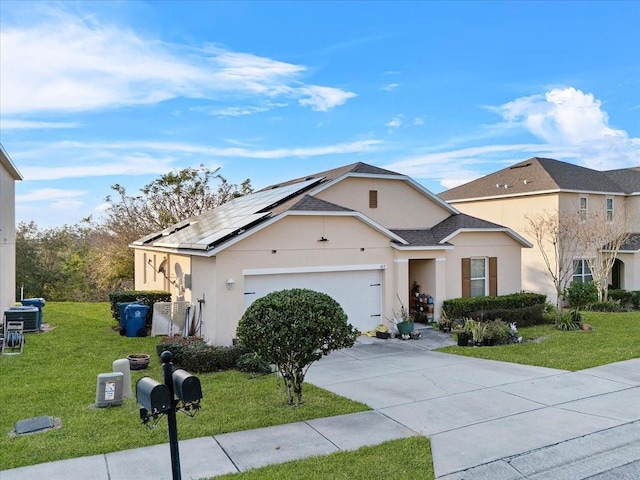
307,329,640,480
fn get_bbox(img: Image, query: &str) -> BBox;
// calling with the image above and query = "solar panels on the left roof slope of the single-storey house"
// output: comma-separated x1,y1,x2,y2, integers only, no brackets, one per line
141,177,322,250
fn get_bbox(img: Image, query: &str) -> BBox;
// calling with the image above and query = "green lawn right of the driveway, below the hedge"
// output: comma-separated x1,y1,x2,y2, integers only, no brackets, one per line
438,312,640,371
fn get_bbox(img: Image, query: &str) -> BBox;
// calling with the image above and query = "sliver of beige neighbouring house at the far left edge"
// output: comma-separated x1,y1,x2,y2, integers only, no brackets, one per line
0,144,22,312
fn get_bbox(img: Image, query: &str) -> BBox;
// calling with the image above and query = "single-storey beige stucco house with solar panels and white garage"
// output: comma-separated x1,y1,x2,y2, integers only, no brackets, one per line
131,163,531,345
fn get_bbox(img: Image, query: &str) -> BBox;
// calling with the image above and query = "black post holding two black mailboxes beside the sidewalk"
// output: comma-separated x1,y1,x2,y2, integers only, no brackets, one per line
136,351,202,480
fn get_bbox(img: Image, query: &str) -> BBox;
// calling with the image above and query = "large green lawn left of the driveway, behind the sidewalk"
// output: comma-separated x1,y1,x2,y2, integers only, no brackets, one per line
0,302,368,470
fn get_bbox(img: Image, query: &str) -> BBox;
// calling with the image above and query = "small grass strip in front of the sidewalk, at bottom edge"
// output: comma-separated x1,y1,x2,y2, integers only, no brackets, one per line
210,437,435,480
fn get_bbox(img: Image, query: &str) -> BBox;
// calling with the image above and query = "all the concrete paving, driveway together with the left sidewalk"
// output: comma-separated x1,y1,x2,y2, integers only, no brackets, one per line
0,329,640,480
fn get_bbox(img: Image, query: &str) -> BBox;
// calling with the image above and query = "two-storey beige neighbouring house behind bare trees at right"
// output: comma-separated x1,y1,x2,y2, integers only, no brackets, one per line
438,157,640,302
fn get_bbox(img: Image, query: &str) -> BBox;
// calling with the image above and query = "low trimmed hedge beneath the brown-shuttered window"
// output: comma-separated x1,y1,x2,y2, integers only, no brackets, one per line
442,293,547,327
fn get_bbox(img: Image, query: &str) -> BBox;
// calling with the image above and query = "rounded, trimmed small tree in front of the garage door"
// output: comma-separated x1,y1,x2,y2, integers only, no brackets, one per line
237,288,357,406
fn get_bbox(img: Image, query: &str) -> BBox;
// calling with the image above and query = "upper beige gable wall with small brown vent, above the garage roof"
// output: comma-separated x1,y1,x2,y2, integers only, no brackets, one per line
315,178,451,229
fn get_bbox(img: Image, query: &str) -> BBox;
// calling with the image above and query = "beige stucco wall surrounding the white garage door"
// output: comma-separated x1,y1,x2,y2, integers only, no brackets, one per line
204,215,395,344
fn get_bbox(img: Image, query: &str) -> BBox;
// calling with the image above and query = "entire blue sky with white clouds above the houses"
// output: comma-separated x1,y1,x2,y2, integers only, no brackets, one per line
0,0,640,228
